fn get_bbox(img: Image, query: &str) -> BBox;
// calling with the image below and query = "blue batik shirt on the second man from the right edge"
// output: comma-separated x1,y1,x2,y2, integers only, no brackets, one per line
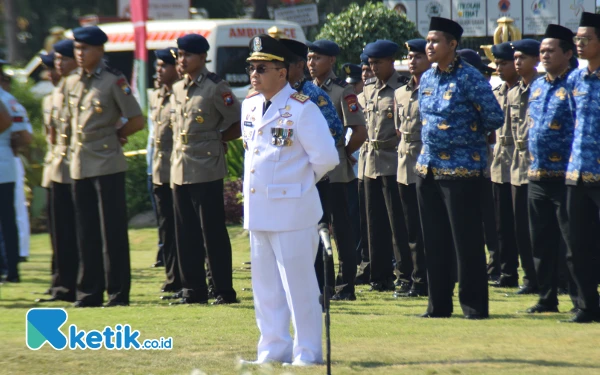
527,69,575,181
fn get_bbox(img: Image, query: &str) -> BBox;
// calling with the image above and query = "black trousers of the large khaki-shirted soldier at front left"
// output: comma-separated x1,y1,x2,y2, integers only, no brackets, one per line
73,172,131,305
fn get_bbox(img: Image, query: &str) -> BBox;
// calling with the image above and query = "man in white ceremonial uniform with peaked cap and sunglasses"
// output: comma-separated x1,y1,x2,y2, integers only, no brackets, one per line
242,35,339,366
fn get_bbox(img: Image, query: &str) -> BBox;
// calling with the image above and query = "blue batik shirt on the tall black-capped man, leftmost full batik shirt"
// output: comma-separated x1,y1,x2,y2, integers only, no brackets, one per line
416,56,504,179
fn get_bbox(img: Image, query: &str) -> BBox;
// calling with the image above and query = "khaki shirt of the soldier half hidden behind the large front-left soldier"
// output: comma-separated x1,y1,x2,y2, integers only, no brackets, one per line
50,77,73,184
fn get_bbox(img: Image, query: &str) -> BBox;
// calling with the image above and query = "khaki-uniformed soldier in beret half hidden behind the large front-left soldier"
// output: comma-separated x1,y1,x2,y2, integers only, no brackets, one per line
36,39,79,302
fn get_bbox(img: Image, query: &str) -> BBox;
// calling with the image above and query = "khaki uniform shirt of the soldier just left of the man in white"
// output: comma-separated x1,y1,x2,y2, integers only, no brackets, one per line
171,68,241,185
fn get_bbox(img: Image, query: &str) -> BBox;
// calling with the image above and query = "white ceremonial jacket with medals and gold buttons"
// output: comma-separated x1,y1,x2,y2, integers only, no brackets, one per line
241,84,340,232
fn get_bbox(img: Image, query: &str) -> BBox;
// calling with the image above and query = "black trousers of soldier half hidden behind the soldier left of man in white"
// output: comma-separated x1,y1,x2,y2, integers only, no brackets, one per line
152,183,181,291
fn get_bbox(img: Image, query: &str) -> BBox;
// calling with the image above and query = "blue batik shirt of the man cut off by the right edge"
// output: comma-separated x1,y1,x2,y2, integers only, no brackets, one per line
566,68,600,185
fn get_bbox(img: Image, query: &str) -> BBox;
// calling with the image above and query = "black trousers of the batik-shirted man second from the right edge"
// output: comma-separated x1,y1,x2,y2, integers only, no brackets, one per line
528,181,569,307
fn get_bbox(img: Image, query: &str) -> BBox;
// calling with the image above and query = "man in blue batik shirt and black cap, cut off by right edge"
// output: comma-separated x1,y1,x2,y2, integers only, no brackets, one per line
566,12,600,323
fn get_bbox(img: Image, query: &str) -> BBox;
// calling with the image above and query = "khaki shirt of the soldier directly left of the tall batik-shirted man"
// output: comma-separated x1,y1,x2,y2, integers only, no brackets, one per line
394,78,423,185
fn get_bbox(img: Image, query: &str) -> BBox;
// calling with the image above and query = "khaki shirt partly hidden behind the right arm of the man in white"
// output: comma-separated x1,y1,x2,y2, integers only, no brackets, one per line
313,72,365,183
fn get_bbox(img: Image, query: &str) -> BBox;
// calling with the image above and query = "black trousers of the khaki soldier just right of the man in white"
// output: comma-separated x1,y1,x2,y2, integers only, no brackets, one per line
315,180,356,293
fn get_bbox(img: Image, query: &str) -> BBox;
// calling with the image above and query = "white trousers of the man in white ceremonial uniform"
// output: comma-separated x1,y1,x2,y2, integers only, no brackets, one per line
250,225,323,363
